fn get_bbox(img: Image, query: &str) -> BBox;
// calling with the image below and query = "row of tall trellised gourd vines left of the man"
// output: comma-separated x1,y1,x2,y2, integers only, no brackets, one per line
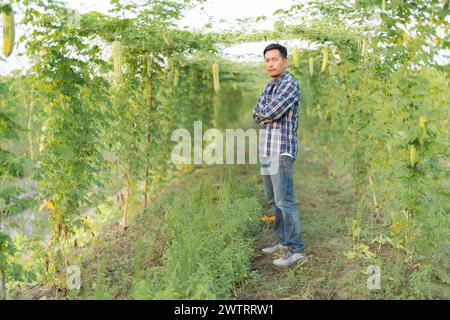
2,0,262,296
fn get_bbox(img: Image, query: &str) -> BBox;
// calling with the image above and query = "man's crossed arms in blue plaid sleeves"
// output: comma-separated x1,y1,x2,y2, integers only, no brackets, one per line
253,82,300,125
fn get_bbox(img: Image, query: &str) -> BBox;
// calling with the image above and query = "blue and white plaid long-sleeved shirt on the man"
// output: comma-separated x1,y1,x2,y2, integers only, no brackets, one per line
253,71,301,159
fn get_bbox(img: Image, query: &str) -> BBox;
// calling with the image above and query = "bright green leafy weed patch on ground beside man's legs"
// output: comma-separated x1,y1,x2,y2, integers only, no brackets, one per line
132,172,259,299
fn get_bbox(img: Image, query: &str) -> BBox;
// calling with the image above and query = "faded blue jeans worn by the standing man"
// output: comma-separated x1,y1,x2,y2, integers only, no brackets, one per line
263,156,305,253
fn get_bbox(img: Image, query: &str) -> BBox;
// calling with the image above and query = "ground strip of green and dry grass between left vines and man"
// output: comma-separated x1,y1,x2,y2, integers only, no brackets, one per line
81,167,260,299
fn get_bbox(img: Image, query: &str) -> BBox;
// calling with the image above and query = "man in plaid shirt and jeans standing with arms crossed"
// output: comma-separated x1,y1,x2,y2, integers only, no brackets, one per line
253,44,306,267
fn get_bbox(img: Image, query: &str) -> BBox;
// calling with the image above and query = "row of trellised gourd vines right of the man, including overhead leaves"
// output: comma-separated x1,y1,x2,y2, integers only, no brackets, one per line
276,1,450,297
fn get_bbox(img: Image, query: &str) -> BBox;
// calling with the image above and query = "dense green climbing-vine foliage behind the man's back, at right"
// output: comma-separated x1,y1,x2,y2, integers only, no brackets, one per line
286,4,450,296
